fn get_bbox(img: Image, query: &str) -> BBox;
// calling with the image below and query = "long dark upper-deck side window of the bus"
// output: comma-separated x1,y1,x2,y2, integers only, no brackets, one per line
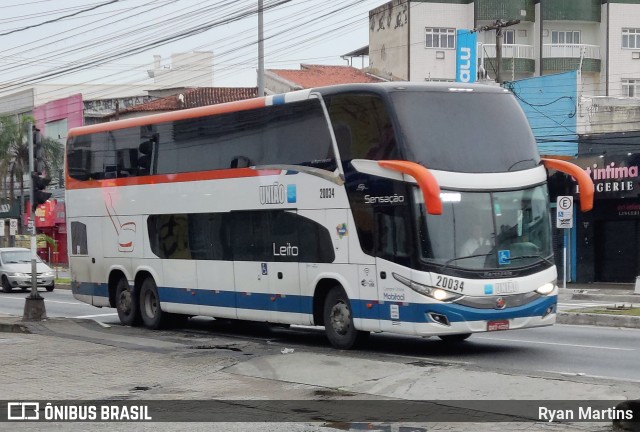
67,99,335,180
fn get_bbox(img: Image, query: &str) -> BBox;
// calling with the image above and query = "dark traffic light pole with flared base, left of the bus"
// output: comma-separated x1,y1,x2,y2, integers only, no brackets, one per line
22,122,47,321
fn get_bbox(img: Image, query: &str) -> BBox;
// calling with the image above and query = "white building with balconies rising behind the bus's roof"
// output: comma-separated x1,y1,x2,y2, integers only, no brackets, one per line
369,0,640,97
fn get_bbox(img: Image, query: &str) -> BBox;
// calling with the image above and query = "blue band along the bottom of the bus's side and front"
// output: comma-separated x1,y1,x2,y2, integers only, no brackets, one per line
72,282,558,323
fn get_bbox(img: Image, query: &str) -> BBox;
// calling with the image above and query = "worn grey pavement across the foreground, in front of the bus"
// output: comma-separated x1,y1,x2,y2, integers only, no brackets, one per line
0,317,637,432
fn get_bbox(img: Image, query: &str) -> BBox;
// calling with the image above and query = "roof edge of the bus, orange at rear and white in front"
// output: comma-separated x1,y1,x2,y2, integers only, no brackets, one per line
68,81,508,138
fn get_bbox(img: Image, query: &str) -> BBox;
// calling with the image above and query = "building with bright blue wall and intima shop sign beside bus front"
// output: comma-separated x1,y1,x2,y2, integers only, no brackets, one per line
505,71,640,283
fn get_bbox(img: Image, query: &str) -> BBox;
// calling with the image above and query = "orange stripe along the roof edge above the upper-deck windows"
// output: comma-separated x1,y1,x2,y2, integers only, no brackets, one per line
67,97,266,138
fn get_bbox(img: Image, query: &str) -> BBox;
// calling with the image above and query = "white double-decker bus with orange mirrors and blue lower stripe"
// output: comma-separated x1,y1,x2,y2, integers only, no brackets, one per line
66,83,593,349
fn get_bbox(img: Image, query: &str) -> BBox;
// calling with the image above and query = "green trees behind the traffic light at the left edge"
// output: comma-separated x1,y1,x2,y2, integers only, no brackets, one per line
0,116,64,202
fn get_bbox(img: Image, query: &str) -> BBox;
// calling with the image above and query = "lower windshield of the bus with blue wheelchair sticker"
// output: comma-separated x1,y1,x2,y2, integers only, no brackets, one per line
414,185,552,270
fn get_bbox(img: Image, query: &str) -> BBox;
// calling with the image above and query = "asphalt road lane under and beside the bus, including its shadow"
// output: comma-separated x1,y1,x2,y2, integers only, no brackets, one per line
0,290,640,383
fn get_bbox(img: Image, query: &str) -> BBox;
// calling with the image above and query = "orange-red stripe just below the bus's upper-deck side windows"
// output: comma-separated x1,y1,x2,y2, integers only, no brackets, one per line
66,168,282,189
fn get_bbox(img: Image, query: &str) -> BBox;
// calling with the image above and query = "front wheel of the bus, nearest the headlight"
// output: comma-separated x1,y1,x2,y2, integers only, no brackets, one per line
323,287,368,349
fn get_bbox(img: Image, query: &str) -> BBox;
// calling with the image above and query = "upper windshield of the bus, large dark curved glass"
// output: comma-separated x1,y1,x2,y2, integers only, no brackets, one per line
390,90,540,173
